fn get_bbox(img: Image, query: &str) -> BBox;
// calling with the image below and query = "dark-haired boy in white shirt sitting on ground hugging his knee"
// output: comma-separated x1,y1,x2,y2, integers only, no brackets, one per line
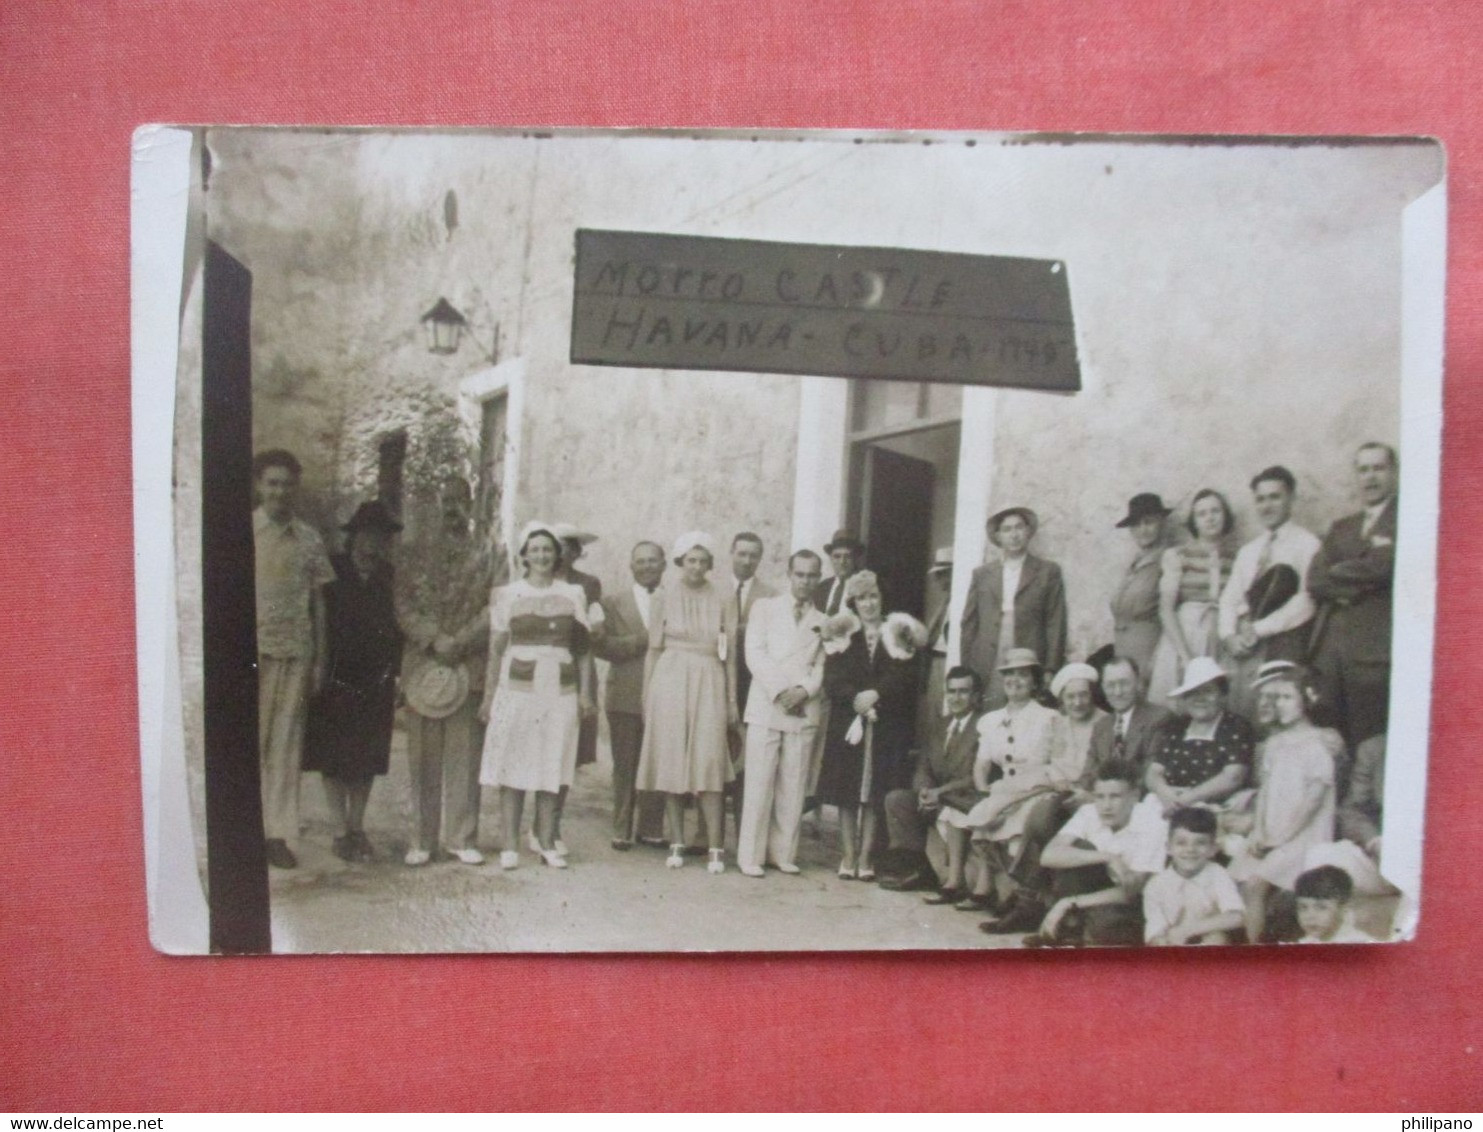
1008,760,1169,947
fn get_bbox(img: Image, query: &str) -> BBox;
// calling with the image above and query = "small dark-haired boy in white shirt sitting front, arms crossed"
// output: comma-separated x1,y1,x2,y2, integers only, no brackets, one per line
1143,806,1246,947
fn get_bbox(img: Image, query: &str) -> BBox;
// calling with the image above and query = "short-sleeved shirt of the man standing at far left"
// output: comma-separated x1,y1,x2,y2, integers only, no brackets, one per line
252,507,335,659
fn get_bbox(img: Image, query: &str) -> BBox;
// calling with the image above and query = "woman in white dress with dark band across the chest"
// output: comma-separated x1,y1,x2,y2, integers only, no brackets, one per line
479,522,593,869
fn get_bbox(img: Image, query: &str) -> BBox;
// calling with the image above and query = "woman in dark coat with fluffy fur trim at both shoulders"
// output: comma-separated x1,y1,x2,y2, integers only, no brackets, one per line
817,570,927,880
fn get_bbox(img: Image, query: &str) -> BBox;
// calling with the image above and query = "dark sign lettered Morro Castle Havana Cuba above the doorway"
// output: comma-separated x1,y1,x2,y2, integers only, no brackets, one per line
571,228,1081,393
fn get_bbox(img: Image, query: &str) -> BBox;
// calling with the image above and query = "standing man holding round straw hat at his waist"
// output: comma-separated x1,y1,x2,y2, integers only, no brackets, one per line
396,476,503,866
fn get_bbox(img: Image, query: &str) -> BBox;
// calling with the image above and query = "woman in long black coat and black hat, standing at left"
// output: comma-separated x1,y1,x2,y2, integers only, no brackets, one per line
304,501,402,860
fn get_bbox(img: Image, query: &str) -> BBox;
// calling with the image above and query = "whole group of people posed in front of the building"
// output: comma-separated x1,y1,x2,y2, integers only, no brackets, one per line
255,444,1397,945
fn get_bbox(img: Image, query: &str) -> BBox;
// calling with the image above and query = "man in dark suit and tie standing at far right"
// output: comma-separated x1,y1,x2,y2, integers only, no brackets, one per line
1308,444,1400,746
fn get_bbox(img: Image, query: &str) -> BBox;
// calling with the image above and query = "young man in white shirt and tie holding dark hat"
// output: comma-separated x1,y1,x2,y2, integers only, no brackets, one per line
1218,464,1320,718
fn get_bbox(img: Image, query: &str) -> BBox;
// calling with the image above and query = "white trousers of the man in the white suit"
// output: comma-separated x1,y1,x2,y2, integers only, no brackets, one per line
737,724,816,868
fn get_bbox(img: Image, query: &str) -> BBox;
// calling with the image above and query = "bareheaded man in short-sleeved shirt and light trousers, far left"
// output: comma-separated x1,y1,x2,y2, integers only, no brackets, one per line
252,448,335,868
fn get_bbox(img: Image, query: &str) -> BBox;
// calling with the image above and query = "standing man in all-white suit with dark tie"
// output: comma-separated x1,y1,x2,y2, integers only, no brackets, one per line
737,550,825,877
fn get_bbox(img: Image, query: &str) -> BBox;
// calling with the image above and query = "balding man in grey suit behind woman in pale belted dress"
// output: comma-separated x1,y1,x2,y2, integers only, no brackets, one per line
593,542,664,852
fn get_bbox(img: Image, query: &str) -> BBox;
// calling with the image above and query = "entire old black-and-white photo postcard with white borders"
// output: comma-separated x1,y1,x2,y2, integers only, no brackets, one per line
132,126,1446,954
